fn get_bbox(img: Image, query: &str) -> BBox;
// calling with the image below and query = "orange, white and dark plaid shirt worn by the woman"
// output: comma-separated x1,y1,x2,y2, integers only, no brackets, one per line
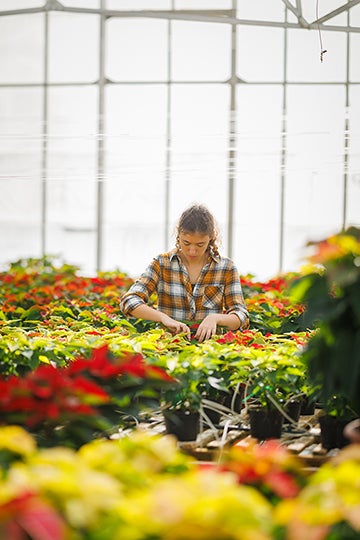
120,250,249,329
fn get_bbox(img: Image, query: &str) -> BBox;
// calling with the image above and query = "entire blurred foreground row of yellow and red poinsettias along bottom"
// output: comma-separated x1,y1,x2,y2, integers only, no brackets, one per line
0,426,360,540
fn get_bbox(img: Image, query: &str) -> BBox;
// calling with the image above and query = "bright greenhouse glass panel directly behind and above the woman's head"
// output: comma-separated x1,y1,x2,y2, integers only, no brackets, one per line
170,84,230,246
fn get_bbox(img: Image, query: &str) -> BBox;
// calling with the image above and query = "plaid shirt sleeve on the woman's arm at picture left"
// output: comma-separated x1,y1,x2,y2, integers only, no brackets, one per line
120,259,160,316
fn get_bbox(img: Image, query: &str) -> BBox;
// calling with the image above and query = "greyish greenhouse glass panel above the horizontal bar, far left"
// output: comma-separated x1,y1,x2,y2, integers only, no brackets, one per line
0,14,44,83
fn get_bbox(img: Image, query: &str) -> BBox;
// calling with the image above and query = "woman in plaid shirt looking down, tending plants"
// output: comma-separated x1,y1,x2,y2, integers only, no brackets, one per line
120,205,249,342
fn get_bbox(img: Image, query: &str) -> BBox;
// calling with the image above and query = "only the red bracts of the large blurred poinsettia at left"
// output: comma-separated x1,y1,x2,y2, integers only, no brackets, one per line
0,345,174,428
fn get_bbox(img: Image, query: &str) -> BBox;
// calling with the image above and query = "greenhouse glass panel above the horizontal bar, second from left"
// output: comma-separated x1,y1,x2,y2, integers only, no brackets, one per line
49,13,100,82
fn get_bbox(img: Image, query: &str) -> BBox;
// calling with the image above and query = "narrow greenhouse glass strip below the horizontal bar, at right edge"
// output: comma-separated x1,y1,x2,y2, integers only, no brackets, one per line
346,86,360,227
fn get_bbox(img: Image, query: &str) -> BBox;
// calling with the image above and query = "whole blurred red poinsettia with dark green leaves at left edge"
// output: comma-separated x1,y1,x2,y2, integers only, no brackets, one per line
0,346,174,448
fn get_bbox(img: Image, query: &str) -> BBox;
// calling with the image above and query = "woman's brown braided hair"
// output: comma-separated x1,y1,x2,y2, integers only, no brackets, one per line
176,204,219,257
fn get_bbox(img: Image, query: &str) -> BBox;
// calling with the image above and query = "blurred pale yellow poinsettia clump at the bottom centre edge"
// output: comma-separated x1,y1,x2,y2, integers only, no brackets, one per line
116,470,272,540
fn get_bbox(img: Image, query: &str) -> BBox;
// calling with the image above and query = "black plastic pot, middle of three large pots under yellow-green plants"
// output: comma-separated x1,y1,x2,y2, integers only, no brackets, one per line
249,406,284,441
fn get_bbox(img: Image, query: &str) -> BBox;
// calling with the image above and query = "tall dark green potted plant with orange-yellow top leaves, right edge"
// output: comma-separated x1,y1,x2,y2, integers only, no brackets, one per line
292,227,360,448
